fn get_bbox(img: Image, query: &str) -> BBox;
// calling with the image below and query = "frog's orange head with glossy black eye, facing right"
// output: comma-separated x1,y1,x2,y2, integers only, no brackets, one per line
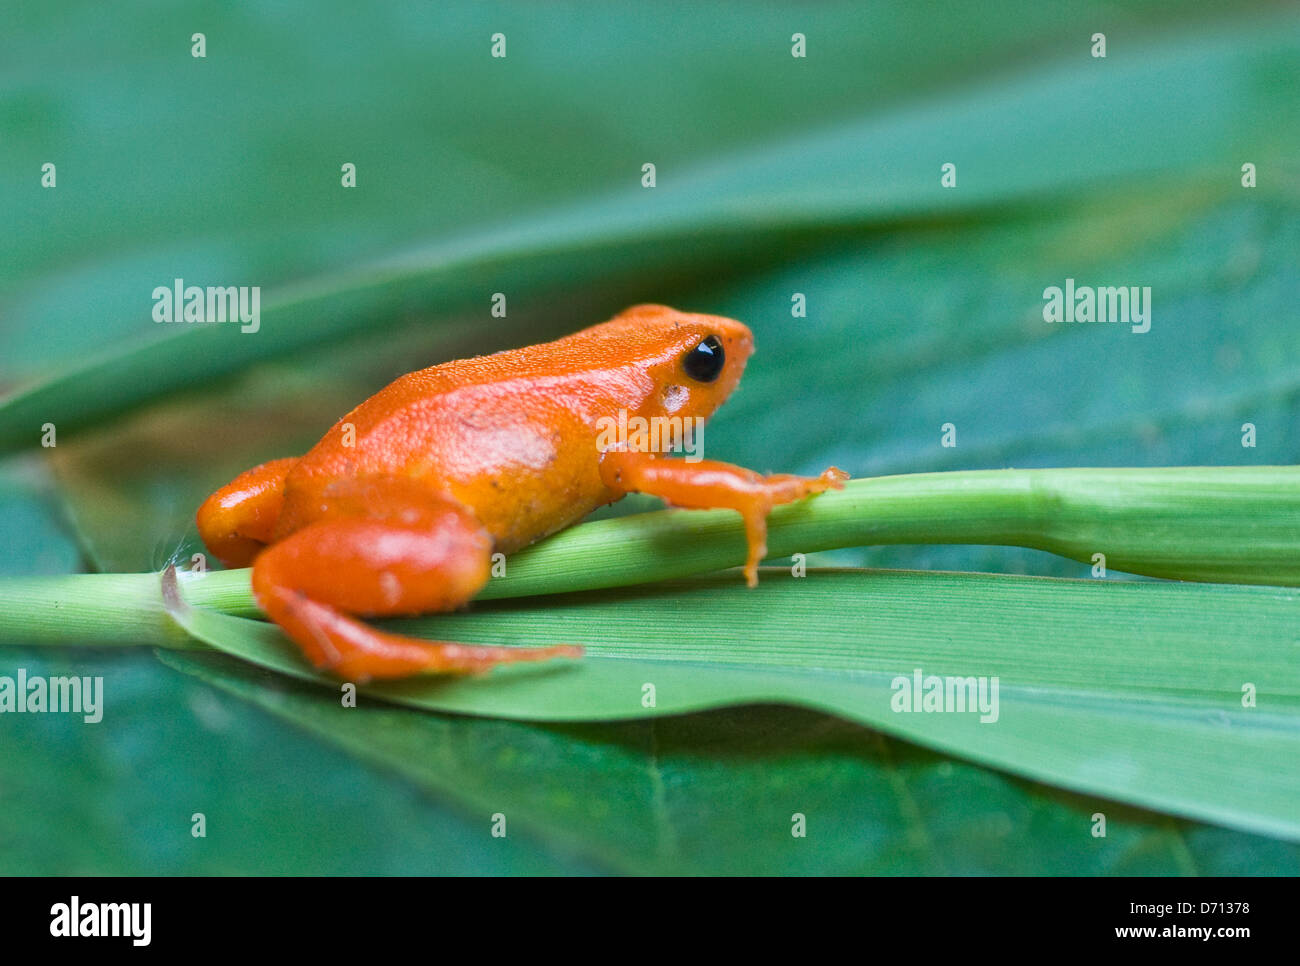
597,306,754,419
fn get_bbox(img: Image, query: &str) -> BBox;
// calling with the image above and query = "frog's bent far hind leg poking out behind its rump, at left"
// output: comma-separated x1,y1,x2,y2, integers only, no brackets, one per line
198,456,298,567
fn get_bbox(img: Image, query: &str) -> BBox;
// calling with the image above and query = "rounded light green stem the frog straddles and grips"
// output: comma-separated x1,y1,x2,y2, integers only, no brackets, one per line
0,467,1300,644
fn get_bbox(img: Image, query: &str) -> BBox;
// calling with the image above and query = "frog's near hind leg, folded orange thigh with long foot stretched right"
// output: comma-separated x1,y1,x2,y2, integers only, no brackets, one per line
252,482,581,681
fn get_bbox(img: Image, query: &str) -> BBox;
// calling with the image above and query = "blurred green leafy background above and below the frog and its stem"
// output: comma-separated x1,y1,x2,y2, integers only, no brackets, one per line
0,3,1300,874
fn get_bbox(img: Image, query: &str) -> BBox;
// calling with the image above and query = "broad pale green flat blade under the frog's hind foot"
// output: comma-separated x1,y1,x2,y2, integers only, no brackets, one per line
159,571,1300,839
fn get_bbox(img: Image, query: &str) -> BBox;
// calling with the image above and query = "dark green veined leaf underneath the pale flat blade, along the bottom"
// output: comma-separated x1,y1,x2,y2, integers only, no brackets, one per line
161,651,1300,875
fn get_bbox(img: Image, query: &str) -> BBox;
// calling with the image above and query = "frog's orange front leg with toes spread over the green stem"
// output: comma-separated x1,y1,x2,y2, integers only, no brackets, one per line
601,449,849,586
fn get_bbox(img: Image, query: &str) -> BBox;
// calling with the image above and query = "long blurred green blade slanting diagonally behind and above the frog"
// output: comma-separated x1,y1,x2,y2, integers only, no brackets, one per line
0,9,1300,451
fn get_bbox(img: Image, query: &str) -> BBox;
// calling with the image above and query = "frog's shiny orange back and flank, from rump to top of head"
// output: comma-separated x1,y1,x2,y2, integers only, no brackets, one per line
277,306,749,549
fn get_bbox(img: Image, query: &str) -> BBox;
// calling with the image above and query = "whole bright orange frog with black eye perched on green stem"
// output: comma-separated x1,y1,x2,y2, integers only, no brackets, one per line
198,306,848,681
